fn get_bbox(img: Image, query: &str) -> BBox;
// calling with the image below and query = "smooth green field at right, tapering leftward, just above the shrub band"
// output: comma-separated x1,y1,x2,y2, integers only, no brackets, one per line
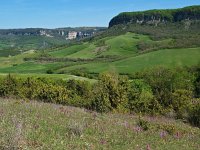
57,48,200,73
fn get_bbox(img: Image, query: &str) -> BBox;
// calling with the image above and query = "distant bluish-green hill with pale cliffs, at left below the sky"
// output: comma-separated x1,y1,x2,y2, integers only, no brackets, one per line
0,27,106,56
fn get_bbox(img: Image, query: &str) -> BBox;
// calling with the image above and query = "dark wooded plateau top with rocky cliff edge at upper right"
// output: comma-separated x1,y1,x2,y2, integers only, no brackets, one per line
109,5,200,27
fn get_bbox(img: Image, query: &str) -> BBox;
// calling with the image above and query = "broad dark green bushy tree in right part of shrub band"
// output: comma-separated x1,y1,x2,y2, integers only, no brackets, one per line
140,67,194,111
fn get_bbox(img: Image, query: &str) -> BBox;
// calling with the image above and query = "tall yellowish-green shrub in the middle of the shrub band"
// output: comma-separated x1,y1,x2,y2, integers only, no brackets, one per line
93,72,129,112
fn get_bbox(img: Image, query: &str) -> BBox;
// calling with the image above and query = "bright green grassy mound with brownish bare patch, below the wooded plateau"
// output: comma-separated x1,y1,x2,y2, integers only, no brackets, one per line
49,33,150,58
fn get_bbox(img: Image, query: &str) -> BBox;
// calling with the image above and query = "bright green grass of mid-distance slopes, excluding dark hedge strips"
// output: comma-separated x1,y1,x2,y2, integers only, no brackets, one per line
0,33,200,73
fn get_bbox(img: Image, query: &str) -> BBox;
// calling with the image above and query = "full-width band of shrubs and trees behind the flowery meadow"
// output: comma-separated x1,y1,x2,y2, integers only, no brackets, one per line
0,66,200,127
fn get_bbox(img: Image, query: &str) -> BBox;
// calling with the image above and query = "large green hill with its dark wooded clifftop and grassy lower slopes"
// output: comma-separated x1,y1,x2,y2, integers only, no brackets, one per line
0,6,200,76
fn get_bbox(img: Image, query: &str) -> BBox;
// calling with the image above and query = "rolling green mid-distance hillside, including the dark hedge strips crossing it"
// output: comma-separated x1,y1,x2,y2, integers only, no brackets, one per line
0,33,200,75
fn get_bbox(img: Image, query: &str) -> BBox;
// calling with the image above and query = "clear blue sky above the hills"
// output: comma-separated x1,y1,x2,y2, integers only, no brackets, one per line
0,0,200,29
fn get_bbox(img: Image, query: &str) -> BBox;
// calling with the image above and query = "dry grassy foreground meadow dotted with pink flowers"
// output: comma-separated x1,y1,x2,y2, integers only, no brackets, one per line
0,99,200,150
